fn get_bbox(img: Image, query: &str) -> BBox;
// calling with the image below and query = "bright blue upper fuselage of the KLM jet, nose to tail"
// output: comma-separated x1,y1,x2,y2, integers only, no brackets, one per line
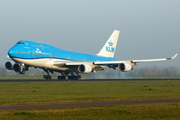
8,40,116,62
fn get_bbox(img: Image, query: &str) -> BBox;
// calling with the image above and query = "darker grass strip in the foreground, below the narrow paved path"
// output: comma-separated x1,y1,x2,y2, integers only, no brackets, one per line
0,103,180,120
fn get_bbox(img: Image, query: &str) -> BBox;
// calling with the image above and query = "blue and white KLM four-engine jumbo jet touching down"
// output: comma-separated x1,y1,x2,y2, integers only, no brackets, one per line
5,30,178,80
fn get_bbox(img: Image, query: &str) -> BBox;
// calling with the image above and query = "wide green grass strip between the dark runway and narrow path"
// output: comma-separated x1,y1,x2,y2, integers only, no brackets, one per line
0,80,180,105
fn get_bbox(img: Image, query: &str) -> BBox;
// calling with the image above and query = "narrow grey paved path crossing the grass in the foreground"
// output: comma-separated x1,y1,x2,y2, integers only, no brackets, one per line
0,99,180,110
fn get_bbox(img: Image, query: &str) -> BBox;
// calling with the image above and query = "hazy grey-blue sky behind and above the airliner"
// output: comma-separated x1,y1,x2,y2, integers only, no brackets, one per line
0,0,180,67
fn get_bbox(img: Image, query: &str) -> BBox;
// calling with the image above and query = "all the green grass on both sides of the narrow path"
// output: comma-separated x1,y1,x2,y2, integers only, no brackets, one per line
0,80,180,120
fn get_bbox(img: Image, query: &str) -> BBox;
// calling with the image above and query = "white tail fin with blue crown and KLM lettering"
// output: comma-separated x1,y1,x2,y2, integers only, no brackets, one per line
97,30,120,57
